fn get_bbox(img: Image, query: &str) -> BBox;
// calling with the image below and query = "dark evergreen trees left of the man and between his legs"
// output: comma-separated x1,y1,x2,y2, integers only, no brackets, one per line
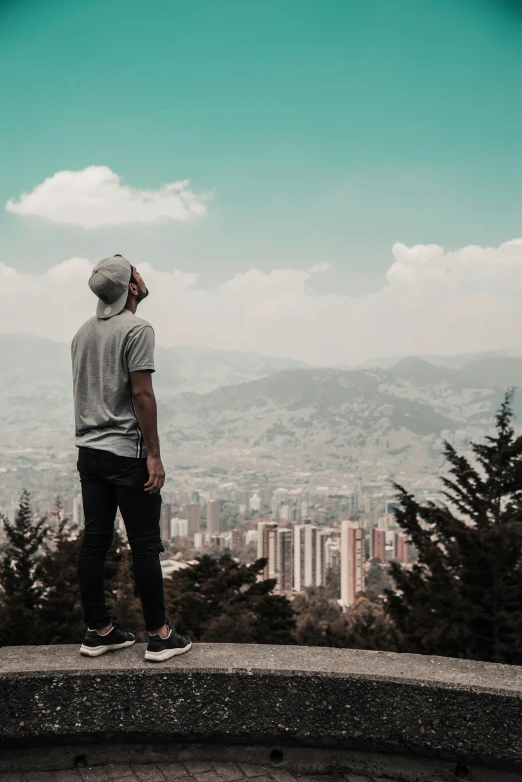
0,491,146,646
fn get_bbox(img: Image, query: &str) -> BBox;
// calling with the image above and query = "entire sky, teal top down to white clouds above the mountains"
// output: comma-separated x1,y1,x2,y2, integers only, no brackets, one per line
0,0,522,365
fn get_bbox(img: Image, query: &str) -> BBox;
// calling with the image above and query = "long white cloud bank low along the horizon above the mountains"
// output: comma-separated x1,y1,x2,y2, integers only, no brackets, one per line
0,240,522,364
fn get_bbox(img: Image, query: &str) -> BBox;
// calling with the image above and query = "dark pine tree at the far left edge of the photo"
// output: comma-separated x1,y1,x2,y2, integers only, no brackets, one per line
0,490,47,646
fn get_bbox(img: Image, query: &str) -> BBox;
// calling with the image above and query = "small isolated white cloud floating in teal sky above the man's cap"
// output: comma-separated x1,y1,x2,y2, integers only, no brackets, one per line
5,166,208,228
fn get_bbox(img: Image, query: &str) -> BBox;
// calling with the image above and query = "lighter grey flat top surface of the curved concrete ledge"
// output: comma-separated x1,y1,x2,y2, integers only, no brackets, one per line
4,644,522,693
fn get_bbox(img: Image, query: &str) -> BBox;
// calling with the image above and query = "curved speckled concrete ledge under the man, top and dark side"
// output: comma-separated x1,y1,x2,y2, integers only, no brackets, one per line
0,644,522,778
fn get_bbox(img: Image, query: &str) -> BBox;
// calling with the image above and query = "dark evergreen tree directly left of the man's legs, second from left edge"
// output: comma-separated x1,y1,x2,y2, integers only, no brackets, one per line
37,500,85,644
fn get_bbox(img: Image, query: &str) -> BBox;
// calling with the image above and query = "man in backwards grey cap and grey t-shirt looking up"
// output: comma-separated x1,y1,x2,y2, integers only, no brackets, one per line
71,255,191,662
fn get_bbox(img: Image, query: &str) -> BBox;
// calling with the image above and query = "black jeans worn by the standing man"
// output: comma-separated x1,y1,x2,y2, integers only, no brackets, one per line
76,447,165,630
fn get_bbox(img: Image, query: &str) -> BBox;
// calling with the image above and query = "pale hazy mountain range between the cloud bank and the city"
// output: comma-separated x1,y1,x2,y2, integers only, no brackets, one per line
0,335,522,478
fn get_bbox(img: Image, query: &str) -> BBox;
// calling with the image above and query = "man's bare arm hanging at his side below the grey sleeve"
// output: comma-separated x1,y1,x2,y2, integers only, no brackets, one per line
129,369,165,494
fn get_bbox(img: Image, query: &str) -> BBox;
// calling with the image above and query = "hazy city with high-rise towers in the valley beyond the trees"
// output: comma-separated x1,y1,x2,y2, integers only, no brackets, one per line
0,483,430,607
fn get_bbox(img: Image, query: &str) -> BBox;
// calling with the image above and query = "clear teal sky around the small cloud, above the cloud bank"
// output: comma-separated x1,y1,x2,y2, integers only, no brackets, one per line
0,0,522,294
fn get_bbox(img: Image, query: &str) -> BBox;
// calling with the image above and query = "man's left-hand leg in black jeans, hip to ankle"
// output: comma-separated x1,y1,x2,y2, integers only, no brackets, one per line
77,449,117,630
